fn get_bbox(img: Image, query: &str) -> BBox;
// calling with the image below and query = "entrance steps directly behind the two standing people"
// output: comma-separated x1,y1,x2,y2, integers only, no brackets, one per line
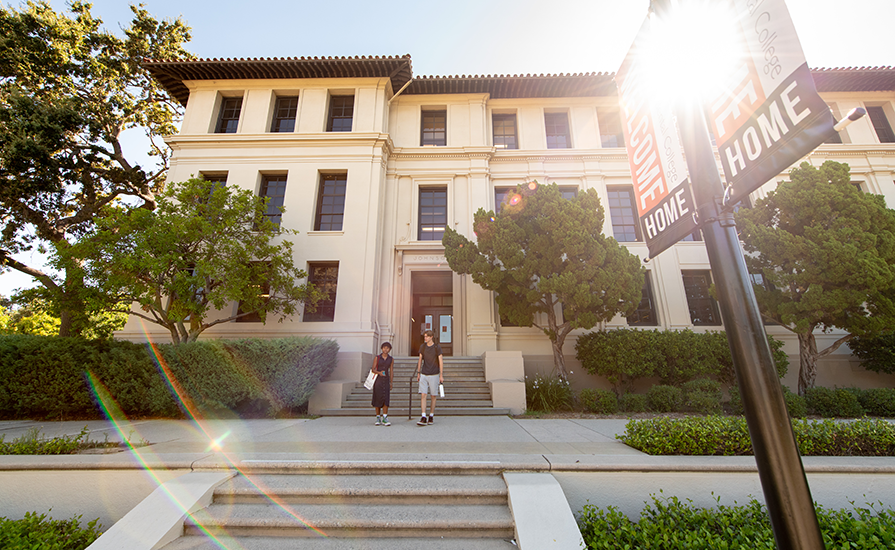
320,357,510,418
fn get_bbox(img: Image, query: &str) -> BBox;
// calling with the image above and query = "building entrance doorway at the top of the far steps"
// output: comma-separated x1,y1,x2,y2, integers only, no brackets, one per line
410,271,454,357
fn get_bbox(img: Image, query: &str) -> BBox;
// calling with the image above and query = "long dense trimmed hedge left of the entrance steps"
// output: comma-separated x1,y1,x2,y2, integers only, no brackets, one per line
0,335,338,419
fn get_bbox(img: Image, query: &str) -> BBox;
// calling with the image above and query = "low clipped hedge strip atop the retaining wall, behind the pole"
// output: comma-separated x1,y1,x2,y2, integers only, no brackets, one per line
616,416,895,456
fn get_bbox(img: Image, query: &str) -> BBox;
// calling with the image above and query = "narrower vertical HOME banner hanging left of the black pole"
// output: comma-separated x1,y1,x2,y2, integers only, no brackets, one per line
615,19,697,257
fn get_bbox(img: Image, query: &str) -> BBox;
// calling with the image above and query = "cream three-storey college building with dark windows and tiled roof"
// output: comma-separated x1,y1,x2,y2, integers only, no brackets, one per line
130,56,895,402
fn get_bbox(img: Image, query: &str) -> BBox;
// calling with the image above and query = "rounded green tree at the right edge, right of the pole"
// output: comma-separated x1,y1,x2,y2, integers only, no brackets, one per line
737,161,895,395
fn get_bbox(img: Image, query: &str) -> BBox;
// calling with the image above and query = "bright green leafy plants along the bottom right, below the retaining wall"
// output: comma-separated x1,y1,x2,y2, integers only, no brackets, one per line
578,495,895,550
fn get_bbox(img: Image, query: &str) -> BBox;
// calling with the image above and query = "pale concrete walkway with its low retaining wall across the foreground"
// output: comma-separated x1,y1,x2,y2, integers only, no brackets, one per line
0,415,895,548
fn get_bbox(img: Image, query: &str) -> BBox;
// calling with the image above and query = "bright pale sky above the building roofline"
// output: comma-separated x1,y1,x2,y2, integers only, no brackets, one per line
0,0,895,296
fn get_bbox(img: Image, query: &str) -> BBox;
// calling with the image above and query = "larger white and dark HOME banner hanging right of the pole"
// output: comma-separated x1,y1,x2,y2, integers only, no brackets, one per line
704,0,835,204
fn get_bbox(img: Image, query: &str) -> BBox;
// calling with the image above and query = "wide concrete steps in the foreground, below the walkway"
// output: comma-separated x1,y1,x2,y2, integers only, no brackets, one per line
163,465,516,550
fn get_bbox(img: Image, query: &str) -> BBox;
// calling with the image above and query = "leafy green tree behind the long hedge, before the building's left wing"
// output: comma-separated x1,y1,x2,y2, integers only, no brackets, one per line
65,179,325,343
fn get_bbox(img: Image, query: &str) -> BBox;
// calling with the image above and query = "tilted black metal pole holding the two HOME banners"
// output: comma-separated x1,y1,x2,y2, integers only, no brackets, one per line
678,102,824,550
